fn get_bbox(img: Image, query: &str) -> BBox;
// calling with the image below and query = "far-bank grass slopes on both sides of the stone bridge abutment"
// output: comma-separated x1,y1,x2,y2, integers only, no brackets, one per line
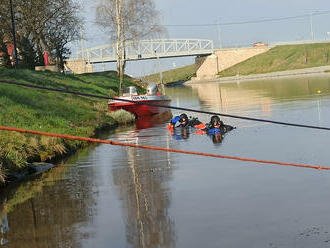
144,43,330,83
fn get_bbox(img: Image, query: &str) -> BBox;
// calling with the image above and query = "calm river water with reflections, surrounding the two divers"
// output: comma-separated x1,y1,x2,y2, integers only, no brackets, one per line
0,76,330,248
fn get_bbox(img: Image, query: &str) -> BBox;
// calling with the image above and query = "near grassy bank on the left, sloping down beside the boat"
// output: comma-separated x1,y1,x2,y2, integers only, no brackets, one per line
0,69,142,184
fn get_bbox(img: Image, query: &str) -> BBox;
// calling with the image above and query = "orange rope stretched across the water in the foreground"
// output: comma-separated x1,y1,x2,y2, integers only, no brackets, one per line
0,126,330,170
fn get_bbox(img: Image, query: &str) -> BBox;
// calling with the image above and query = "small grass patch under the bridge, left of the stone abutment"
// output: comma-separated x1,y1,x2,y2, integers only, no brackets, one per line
143,64,196,84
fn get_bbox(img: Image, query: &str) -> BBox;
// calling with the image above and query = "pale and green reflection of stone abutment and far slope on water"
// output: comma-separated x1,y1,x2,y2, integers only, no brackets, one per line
191,76,330,116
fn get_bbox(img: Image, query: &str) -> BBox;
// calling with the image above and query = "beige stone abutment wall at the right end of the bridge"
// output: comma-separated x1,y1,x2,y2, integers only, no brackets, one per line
194,46,270,80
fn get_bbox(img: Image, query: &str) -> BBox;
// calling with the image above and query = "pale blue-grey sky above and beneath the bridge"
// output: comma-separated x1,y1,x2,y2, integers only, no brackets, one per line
73,0,330,77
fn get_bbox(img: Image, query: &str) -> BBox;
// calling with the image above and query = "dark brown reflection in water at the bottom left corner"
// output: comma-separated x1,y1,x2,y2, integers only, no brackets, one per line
0,155,94,248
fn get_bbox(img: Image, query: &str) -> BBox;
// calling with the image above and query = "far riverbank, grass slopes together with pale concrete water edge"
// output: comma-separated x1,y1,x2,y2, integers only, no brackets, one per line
145,43,330,86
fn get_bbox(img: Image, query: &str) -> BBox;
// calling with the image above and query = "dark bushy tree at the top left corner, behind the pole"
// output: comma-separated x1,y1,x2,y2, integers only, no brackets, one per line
0,0,81,67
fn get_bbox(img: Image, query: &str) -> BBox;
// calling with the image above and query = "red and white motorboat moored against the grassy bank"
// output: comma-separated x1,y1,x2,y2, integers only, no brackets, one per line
109,83,171,116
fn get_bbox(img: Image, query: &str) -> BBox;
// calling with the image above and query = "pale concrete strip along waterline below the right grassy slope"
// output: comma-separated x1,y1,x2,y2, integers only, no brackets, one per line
185,66,330,84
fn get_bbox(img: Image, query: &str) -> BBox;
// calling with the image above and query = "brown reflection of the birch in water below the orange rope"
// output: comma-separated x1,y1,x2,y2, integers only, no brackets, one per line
113,134,175,247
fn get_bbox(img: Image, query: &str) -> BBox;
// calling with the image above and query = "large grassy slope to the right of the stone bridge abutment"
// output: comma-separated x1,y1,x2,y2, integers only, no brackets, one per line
219,43,330,77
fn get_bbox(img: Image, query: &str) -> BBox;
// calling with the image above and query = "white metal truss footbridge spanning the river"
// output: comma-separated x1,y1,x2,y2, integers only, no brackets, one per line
76,39,213,64
